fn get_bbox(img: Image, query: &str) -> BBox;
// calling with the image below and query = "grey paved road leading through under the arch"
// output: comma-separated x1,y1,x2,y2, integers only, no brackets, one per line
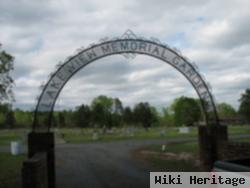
56,139,194,188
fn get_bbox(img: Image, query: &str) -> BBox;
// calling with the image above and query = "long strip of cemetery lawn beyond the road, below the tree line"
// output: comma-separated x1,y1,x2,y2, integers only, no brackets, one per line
0,126,250,146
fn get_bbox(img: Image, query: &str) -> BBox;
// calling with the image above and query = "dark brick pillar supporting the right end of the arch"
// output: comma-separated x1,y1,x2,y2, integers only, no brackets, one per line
198,125,228,171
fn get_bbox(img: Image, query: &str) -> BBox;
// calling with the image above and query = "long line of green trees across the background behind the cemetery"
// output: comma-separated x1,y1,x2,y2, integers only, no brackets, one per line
0,89,250,130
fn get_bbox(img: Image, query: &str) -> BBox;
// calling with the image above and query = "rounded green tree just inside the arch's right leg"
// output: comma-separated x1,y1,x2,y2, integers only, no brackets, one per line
171,96,201,126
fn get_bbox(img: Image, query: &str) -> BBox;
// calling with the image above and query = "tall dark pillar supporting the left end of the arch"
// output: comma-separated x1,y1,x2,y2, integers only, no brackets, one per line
28,132,56,188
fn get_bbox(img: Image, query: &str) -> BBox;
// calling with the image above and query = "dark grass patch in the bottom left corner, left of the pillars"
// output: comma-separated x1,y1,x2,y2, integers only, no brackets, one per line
0,153,26,188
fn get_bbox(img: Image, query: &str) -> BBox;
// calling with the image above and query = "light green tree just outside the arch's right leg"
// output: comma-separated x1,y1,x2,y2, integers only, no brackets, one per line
217,103,237,119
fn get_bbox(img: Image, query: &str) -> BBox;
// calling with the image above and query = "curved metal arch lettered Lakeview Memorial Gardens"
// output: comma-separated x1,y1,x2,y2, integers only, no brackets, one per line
33,34,219,131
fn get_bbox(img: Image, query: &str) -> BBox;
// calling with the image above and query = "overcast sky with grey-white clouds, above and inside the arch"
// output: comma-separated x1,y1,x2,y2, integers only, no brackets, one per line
0,0,250,109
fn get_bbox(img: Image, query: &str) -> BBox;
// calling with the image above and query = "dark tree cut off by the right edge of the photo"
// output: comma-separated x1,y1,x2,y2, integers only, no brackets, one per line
239,89,250,123
